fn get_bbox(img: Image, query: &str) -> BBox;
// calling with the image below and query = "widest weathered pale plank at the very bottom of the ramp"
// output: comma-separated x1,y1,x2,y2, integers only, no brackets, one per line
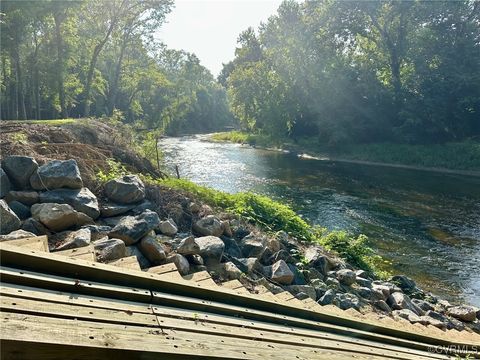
0,313,394,360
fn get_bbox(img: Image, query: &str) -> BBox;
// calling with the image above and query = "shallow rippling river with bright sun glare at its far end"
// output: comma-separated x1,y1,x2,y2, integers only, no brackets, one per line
159,135,480,306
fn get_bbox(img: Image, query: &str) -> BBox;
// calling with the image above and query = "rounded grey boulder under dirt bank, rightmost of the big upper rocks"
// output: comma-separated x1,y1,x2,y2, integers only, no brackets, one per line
105,175,145,204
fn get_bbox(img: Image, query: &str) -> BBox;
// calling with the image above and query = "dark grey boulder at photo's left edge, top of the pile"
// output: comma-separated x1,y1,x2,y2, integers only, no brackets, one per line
2,155,38,190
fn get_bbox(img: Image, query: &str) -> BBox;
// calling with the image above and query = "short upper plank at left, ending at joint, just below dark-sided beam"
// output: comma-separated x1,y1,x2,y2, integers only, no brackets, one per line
0,267,151,302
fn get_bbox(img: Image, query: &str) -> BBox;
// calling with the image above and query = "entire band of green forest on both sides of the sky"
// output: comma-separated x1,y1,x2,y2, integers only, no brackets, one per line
0,0,480,145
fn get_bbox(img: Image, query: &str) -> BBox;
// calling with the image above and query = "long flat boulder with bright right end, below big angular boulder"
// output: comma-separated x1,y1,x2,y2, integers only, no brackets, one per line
40,188,100,219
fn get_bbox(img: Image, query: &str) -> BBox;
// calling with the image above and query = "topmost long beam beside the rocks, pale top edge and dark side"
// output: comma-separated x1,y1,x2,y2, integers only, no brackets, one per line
0,243,480,348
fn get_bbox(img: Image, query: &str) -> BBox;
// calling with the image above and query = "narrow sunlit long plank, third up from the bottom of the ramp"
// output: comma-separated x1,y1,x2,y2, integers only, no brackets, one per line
0,284,450,359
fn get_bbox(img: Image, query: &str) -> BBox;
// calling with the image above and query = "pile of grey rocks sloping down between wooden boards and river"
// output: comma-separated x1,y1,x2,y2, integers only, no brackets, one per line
0,156,480,331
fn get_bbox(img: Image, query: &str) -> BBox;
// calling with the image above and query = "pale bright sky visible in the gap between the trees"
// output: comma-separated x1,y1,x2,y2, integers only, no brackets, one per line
156,0,282,76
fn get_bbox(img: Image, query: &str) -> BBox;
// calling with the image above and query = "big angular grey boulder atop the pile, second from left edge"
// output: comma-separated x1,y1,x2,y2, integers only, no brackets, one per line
30,159,83,190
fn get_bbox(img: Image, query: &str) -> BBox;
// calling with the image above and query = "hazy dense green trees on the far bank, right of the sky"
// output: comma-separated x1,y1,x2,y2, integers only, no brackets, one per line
223,0,480,145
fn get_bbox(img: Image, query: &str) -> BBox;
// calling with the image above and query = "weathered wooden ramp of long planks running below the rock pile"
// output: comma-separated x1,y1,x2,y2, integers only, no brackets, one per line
0,240,480,360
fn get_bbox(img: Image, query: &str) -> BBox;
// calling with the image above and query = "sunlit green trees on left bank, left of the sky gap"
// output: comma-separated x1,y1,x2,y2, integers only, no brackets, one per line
0,0,231,134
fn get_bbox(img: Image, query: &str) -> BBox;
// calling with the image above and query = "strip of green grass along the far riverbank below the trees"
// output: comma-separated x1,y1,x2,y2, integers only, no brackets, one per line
212,131,480,171
